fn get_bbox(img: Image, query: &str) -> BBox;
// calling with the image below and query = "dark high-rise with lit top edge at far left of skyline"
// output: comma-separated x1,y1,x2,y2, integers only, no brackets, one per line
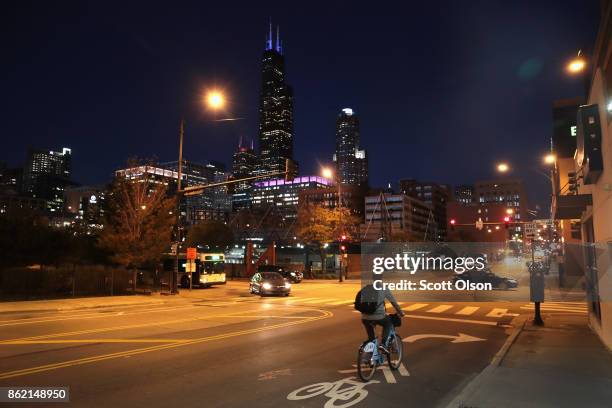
22,147,74,212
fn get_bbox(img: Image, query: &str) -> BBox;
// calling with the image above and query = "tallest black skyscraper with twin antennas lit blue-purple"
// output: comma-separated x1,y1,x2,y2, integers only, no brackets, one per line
257,23,293,174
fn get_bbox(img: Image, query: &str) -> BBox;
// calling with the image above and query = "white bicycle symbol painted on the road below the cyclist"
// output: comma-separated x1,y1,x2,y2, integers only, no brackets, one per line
287,377,380,408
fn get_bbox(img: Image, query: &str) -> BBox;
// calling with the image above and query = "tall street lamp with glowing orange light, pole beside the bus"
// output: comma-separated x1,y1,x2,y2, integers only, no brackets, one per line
171,90,225,294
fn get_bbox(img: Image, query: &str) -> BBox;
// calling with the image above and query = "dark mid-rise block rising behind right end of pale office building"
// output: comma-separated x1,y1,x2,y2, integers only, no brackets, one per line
399,179,450,242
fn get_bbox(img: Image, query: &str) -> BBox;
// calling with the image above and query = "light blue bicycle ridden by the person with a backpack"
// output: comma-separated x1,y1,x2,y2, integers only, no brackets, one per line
357,312,404,382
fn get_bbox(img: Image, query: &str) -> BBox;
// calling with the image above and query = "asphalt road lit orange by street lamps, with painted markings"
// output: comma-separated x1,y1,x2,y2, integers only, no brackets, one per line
0,282,584,408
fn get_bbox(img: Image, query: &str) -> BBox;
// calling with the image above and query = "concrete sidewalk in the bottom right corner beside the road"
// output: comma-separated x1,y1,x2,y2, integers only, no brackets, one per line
448,315,612,408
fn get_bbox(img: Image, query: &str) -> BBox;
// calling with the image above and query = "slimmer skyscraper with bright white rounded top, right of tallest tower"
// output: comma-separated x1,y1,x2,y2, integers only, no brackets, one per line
334,108,368,185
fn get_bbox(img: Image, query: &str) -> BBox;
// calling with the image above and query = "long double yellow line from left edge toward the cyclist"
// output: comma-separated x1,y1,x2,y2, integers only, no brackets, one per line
0,310,333,380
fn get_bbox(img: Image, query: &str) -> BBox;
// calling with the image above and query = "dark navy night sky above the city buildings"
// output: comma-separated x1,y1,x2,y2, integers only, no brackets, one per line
0,0,599,207
